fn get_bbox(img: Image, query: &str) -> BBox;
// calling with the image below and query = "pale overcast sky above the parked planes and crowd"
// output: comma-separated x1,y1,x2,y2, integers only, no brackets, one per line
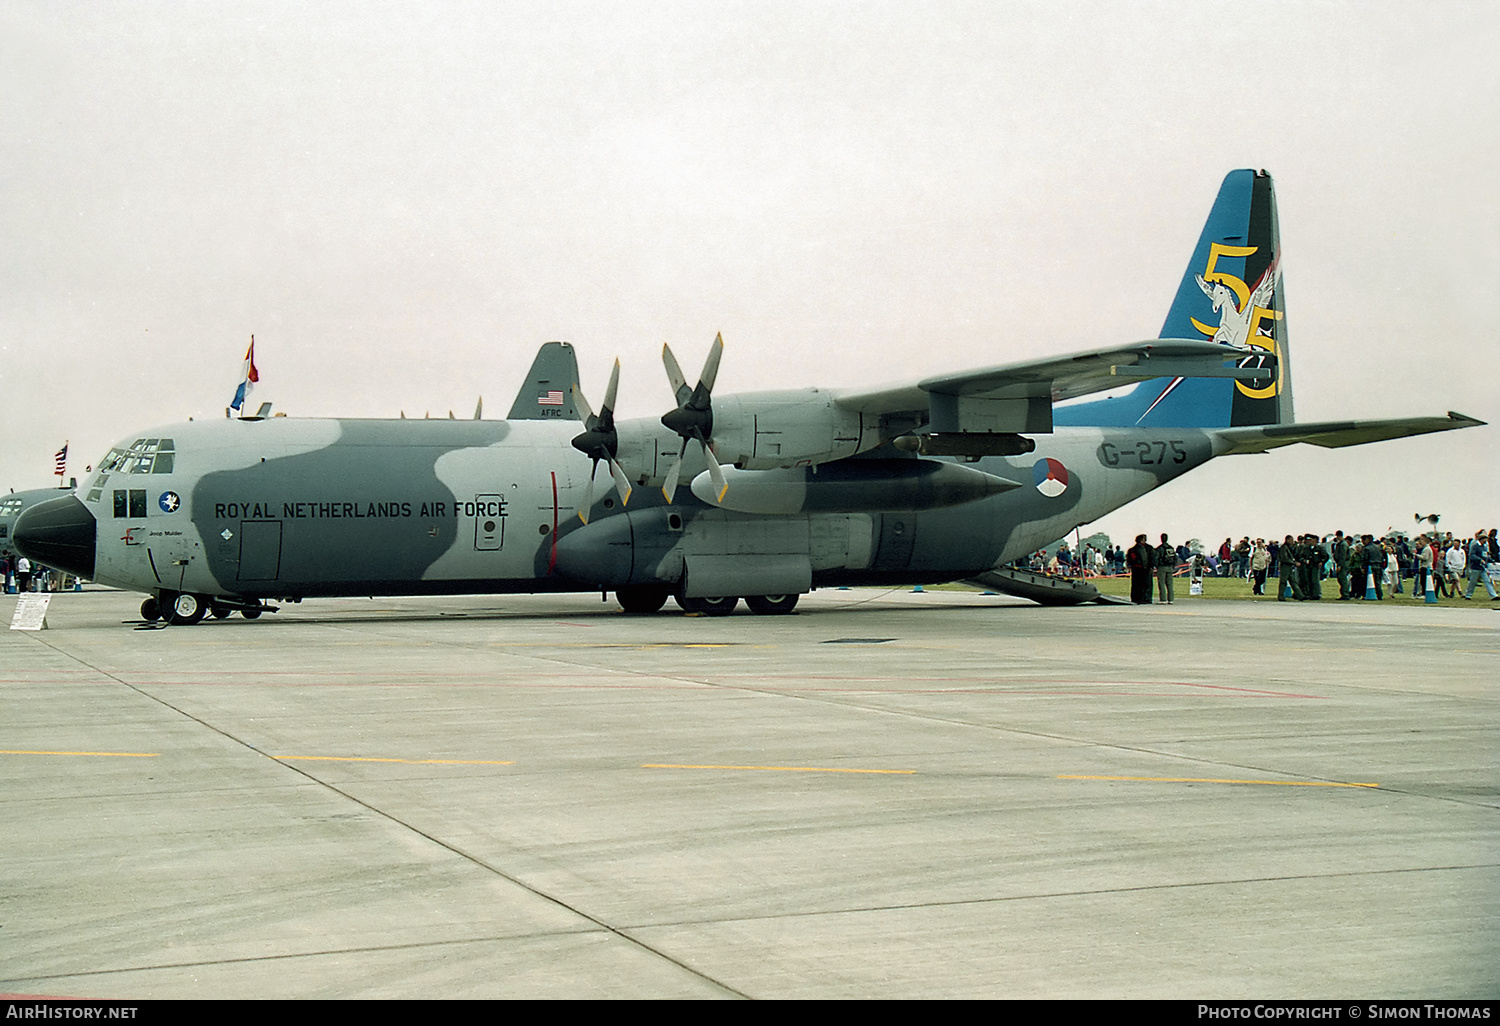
0,0,1500,543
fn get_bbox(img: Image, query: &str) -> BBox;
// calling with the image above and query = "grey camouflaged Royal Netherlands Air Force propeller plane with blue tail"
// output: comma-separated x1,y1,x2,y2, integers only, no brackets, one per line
14,171,1482,624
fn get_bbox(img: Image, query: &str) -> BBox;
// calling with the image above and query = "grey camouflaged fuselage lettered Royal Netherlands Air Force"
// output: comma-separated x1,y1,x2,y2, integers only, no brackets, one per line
38,419,1214,600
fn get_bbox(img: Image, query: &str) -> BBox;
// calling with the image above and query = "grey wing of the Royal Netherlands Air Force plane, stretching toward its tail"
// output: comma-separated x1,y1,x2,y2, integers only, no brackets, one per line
836,339,1277,432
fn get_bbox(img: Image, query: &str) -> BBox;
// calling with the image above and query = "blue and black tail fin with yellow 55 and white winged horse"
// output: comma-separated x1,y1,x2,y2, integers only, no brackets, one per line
1053,171,1292,428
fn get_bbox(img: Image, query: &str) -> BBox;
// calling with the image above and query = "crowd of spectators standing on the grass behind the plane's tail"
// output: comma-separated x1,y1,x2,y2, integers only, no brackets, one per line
1022,528,1500,603
